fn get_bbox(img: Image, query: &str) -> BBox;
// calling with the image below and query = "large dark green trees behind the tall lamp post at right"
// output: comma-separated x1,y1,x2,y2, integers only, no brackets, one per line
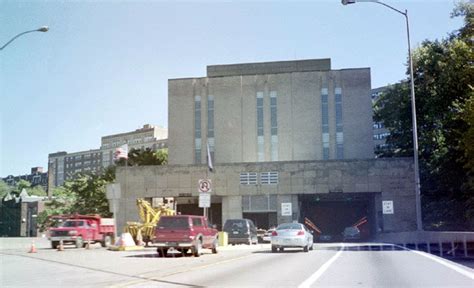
375,3,474,229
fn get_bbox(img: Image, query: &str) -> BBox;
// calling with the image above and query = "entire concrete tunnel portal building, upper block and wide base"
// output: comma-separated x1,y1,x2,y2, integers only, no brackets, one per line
117,59,416,239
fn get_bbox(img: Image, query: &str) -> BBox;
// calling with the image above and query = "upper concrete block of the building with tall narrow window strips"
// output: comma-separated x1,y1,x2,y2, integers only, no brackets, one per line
168,59,374,165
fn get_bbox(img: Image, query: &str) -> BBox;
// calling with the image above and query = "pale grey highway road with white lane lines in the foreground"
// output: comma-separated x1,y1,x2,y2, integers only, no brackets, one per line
0,239,474,287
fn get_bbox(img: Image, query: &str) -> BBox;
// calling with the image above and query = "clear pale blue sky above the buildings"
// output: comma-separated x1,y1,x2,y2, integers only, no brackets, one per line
0,0,462,177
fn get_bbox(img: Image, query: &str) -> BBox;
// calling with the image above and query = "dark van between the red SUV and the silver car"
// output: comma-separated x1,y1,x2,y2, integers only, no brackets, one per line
224,219,258,245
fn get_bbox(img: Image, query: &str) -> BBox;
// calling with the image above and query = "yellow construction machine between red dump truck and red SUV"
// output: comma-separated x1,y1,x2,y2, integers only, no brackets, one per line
125,198,176,245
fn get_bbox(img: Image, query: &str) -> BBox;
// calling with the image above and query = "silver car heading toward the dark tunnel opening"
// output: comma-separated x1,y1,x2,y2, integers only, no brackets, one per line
271,223,313,252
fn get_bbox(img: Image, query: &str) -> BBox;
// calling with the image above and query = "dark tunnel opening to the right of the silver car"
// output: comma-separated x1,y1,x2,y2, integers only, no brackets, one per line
299,193,376,242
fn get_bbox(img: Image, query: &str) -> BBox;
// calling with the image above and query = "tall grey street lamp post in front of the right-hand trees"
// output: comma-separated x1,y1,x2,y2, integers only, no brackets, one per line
341,0,423,231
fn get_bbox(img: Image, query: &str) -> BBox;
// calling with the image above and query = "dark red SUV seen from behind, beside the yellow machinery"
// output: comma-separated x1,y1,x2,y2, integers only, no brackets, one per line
153,215,219,257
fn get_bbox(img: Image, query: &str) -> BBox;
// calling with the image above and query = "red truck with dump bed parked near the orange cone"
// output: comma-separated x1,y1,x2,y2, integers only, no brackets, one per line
48,215,114,249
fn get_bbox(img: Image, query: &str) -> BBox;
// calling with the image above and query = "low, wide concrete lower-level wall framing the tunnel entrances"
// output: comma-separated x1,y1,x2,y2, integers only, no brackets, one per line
116,158,416,232
